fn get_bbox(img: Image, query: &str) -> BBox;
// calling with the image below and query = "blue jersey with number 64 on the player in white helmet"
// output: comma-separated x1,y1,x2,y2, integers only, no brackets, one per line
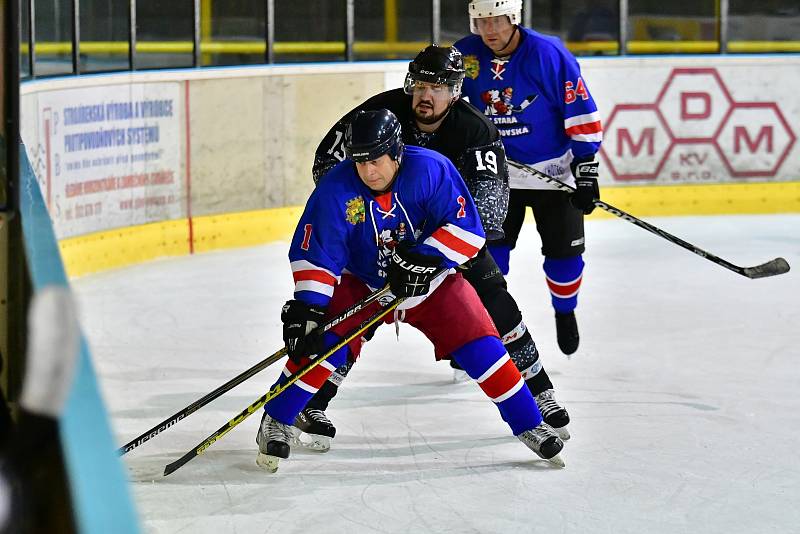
455,26,603,189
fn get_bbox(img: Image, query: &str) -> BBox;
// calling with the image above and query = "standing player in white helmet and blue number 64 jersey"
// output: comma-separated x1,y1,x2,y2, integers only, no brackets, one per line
455,0,602,354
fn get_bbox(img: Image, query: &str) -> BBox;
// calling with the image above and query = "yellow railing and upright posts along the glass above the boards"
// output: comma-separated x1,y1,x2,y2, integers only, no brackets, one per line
20,0,800,77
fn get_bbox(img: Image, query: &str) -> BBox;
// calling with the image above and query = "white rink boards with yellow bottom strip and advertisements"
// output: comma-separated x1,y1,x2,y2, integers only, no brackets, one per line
22,55,800,276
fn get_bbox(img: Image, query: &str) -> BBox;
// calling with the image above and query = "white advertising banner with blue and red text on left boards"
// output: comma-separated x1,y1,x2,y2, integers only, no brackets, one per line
27,82,185,239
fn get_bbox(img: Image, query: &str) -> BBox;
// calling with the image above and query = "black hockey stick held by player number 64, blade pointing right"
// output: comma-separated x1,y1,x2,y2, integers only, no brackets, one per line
506,160,789,278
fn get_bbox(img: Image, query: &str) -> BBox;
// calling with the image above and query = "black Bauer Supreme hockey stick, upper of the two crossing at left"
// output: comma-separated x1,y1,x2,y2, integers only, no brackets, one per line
117,285,389,456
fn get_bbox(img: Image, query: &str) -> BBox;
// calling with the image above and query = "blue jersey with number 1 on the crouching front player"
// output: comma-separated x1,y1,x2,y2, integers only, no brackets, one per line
289,146,485,305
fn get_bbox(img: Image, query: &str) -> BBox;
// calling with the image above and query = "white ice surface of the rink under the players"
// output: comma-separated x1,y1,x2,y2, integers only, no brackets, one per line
73,215,800,534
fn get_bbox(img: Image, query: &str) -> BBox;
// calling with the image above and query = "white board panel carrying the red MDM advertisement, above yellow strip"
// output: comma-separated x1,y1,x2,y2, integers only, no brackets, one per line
582,57,800,185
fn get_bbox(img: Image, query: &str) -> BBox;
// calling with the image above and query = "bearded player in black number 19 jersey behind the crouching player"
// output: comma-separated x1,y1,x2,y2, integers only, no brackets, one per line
295,45,569,451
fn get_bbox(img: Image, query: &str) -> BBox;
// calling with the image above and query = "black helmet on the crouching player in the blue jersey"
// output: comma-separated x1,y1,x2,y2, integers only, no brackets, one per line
344,109,403,163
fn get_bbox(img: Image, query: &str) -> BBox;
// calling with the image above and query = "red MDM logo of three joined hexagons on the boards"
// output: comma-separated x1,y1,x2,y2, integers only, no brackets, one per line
601,68,796,182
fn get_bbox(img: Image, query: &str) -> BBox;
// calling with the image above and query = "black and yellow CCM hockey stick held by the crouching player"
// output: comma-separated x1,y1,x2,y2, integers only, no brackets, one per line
164,288,405,476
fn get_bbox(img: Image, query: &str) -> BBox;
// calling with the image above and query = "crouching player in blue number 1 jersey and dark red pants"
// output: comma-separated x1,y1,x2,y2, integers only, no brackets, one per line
256,109,563,472
